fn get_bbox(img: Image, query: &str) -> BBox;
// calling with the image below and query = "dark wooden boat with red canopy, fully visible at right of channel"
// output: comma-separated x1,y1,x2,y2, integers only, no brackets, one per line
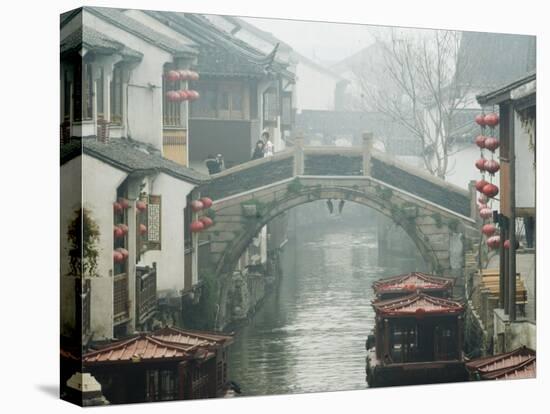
366,291,467,387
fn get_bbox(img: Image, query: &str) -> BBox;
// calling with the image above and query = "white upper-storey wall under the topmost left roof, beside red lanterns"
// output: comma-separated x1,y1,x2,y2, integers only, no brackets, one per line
83,11,173,151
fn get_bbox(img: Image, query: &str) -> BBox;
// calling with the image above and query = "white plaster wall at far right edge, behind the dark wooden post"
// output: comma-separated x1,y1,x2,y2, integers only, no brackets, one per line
514,113,535,208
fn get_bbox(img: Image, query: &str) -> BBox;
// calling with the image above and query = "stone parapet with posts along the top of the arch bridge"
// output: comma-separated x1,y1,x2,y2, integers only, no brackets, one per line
201,134,472,217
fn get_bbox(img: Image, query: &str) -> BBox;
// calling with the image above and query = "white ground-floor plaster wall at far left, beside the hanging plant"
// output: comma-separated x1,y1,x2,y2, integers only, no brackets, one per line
82,155,127,339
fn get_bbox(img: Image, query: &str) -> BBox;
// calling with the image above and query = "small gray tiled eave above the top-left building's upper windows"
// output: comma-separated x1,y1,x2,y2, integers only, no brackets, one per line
61,26,143,59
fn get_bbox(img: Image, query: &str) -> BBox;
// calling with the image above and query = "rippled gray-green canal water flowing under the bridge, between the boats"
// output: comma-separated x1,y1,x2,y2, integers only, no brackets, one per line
229,209,418,395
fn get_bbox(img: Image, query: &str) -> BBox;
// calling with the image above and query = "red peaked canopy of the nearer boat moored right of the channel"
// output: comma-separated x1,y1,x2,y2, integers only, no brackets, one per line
372,292,464,318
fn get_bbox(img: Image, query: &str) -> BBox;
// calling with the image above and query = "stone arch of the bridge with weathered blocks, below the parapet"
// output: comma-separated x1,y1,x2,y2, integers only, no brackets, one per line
208,176,473,274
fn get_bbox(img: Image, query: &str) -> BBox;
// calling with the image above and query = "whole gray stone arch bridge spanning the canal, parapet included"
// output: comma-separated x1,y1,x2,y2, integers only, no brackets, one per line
200,134,479,318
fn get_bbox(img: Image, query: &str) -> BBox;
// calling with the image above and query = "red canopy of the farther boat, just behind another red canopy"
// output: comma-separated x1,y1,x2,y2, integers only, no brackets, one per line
372,272,454,295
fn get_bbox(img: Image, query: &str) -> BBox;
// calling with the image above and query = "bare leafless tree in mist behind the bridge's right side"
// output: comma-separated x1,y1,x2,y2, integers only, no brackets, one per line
351,29,473,179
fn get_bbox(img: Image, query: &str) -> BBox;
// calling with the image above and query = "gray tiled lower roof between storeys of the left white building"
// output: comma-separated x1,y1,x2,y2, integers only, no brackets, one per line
61,137,209,184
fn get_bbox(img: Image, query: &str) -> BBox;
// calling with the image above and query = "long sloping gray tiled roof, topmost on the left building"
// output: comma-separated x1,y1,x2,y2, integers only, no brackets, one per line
84,7,197,55
